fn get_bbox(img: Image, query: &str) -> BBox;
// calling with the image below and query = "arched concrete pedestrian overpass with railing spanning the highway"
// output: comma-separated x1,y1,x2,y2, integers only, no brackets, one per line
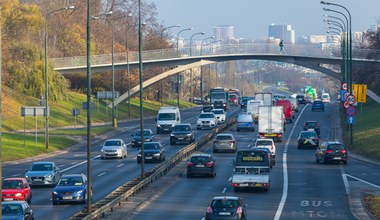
52,43,380,105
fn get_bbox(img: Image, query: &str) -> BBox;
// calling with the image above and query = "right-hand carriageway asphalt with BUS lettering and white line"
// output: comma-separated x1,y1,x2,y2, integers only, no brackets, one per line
122,103,380,220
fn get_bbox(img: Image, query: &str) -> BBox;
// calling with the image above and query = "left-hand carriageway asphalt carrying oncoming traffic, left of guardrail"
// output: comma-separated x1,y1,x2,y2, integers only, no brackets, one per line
3,105,240,220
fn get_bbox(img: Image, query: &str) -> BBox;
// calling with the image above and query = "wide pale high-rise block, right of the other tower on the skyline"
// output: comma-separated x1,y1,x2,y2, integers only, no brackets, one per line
268,24,296,44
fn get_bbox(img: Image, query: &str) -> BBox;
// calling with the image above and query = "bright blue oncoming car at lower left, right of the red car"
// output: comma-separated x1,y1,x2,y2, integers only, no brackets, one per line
51,174,88,205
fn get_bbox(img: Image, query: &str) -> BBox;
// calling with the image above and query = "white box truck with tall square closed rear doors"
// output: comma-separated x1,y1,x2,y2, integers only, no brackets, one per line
258,106,286,142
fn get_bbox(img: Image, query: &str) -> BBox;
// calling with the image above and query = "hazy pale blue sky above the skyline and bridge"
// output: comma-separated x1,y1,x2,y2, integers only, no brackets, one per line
146,0,380,38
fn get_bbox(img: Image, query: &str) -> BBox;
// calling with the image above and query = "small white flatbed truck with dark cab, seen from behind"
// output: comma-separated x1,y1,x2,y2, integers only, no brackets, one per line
230,149,270,192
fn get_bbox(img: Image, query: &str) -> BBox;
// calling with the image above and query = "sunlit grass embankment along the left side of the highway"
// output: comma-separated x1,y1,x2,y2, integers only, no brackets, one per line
1,87,196,161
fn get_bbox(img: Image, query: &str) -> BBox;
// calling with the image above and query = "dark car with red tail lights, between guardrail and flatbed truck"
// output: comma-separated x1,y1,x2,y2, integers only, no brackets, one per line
186,154,216,178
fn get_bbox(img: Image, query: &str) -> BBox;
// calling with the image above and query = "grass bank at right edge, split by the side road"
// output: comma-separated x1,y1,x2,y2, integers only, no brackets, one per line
345,98,380,219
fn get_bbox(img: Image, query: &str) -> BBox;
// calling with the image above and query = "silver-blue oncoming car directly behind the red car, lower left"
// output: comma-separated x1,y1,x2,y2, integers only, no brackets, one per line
25,161,61,186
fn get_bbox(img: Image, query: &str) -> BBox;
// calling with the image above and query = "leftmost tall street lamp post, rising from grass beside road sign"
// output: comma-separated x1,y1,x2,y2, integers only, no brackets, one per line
45,6,75,149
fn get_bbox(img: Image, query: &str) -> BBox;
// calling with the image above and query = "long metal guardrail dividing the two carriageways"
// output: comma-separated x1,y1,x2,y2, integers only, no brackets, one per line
69,116,236,220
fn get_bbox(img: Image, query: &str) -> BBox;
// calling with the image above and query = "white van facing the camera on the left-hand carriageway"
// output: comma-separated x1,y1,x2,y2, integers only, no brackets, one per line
156,106,181,134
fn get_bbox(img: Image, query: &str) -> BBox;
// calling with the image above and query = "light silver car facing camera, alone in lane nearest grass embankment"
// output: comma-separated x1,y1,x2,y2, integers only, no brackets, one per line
100,139,127,160
